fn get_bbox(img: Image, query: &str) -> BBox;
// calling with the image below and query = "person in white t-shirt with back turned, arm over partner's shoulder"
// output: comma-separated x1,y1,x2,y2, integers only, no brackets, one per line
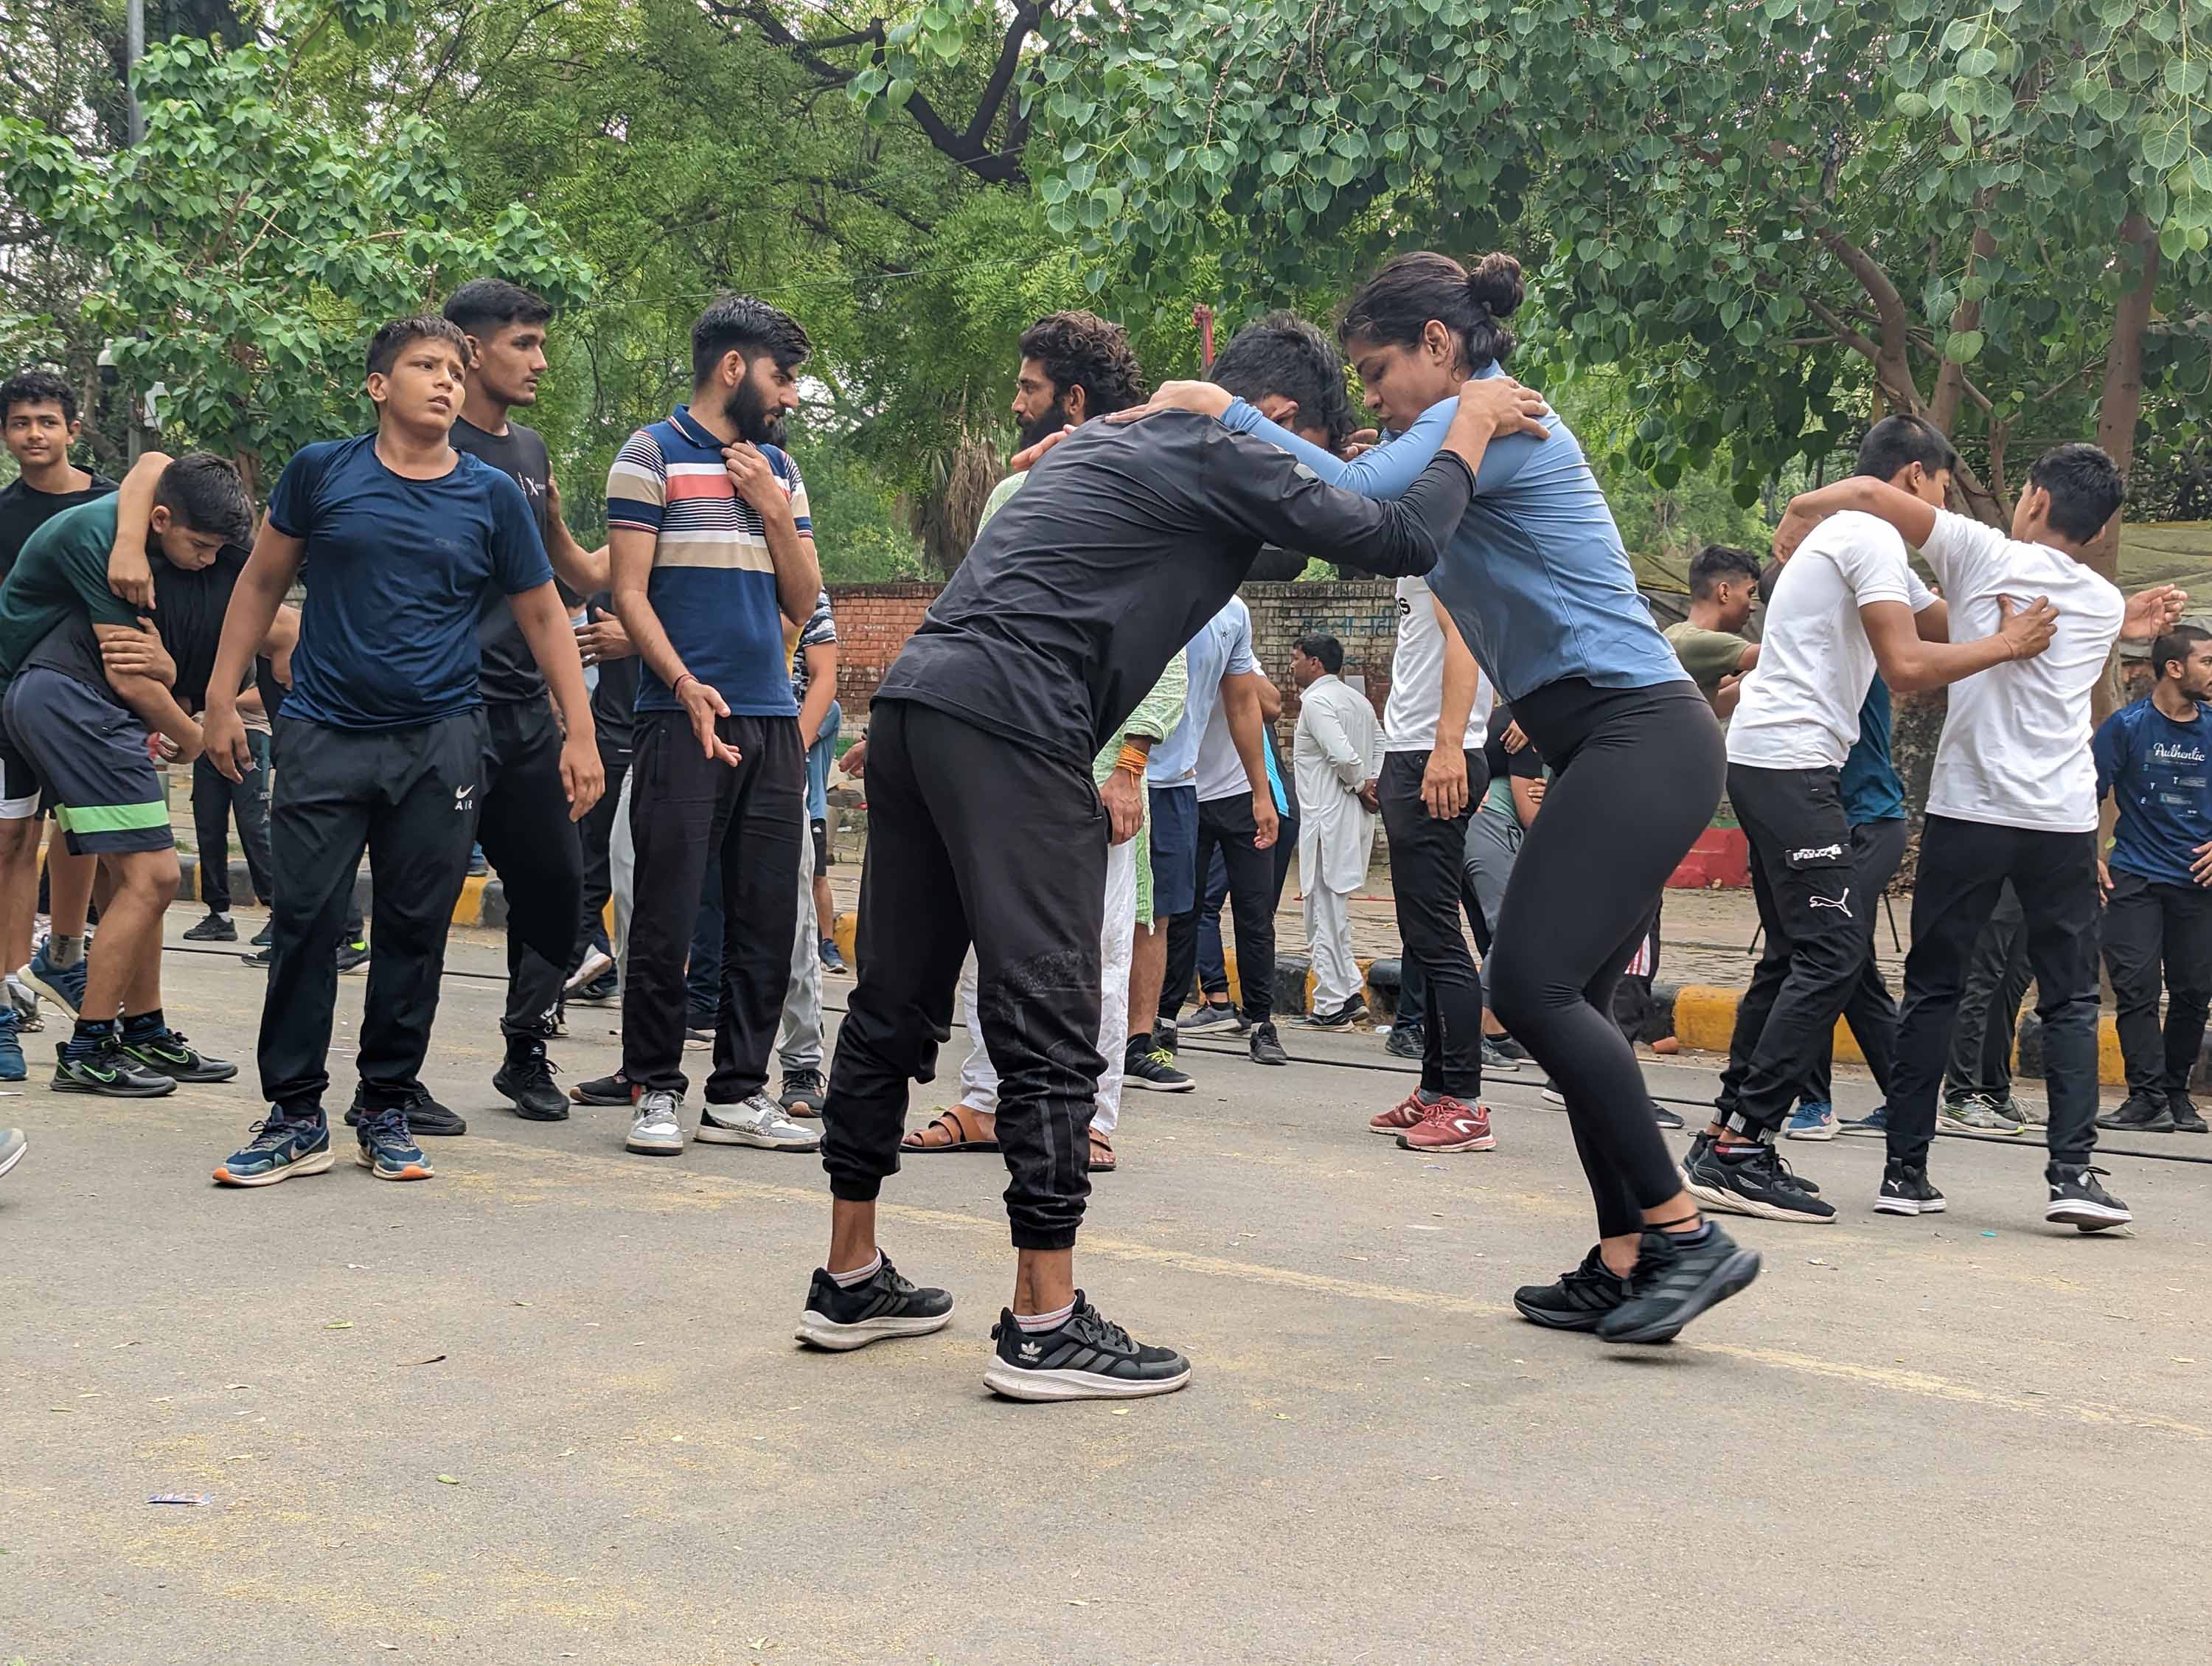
1770,445,2188,1232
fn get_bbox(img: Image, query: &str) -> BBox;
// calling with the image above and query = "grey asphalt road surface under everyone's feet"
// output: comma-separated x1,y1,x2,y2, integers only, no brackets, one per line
0,909,2212,1666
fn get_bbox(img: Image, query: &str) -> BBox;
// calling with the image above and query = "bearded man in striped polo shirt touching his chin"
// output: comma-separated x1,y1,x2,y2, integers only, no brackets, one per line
606,296,821,1155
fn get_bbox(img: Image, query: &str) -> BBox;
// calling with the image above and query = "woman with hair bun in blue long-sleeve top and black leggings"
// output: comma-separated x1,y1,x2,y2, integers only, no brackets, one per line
1124,254,1759,1341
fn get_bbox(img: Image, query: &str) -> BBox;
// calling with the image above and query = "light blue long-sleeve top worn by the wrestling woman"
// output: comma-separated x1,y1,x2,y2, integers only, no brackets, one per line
1221,365,1690,701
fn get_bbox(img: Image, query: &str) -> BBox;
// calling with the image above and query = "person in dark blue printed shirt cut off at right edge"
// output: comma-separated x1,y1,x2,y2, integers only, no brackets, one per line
2090,624,2212,1133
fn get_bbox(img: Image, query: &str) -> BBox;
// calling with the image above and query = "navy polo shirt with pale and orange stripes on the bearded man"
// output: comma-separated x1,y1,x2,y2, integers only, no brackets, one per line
606,405,814,717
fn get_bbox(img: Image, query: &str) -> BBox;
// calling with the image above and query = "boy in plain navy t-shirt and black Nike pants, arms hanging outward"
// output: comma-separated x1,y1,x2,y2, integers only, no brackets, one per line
204,319,604,1186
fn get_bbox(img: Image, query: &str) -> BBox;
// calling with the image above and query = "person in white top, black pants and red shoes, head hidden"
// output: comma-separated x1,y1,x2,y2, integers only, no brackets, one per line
1367,577,1498,1150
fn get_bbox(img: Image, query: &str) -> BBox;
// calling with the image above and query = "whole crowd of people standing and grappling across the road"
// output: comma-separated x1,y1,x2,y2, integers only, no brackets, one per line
0,252,2185,1401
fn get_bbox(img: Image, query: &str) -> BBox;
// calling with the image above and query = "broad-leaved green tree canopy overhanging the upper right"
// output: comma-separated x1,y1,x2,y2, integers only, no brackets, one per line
1042,0,2212,562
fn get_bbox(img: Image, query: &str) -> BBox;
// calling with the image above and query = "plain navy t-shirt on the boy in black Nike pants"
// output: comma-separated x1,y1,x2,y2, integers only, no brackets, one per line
270,434,553,730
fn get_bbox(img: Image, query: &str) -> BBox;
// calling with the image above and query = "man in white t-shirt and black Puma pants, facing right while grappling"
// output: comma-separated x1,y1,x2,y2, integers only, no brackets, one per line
1683,416,2051,1221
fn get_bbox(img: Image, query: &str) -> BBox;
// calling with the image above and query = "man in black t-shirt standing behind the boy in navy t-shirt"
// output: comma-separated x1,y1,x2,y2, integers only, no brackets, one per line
445,279,617,1122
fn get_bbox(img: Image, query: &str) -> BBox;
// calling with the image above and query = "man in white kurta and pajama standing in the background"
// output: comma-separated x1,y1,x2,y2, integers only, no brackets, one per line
1290,637,1382,1027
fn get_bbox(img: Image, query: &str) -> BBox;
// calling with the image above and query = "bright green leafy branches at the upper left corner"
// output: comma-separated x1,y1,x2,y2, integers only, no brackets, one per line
0,0,588,480
